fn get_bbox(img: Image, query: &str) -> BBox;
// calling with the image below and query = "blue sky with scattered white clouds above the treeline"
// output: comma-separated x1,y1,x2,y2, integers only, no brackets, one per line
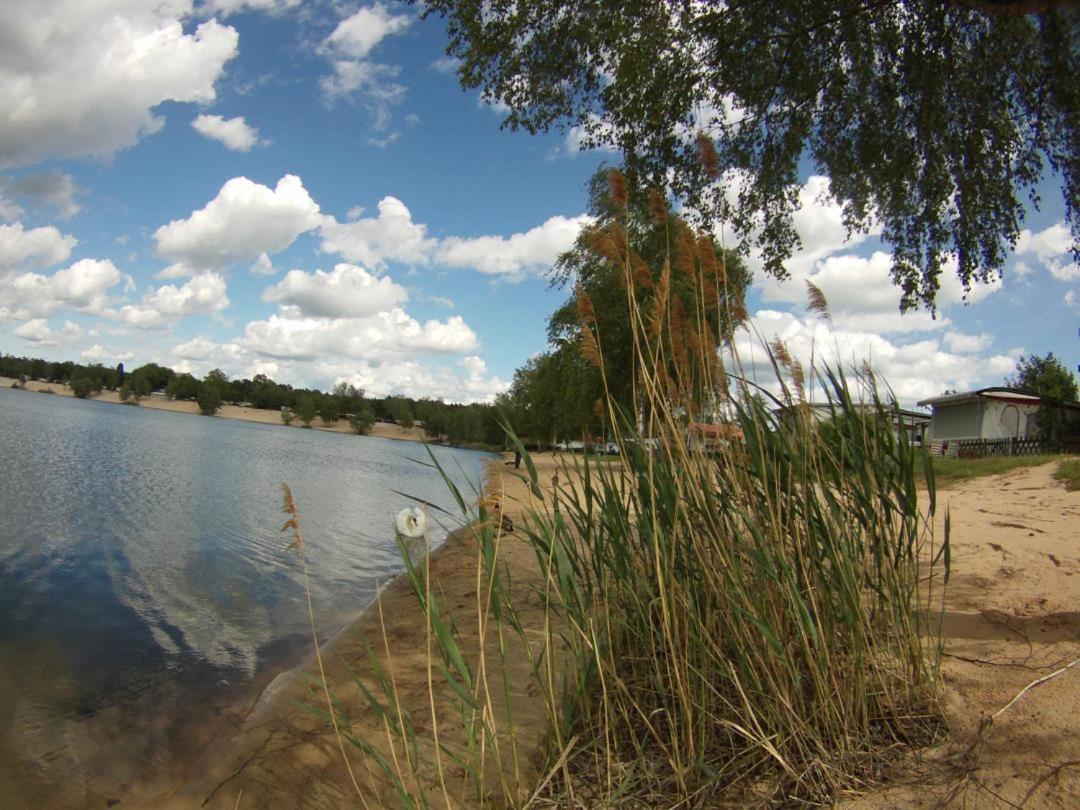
0,0,1080,405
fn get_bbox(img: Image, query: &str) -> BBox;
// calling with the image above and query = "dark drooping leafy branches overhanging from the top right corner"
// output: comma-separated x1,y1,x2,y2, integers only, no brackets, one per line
424,0,1080,309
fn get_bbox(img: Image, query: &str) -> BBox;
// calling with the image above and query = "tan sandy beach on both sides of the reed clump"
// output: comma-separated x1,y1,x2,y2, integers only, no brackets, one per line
160,456,1080,808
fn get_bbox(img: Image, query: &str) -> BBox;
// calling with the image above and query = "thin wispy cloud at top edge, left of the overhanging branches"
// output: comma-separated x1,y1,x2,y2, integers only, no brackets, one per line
319,3,415,132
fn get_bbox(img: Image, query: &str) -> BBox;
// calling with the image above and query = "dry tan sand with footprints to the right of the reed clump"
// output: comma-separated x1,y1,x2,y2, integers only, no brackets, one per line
852,463,1080,808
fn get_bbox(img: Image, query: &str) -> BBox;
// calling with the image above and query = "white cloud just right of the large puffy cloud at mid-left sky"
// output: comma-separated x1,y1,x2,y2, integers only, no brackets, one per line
320,197,436,268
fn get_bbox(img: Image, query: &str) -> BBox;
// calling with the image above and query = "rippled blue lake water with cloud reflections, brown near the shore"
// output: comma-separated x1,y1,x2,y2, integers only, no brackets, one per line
0,389,486,807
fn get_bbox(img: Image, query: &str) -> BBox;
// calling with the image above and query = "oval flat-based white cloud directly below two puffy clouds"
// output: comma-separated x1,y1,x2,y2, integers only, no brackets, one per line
262,264,408,318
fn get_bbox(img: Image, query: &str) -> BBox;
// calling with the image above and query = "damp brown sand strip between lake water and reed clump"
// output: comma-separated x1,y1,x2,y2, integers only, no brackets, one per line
162,457,556,809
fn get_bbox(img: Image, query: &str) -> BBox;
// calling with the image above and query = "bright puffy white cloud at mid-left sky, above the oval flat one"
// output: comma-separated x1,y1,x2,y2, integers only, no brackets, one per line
153,174,323,278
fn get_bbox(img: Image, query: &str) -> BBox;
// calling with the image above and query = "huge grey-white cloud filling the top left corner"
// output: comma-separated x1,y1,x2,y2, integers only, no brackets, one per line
0,0,239,166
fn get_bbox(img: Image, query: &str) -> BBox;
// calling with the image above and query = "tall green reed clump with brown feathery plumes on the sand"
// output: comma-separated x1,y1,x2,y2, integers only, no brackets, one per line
291,168,949,807
